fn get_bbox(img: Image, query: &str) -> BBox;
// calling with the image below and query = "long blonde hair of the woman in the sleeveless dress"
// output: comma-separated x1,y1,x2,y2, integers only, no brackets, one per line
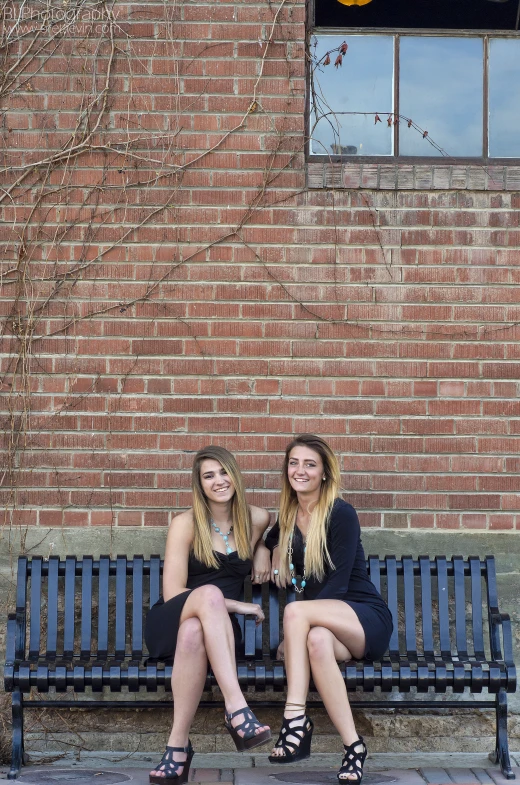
191,445,252,567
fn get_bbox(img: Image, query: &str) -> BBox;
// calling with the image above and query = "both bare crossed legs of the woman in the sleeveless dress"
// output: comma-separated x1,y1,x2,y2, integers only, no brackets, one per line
151,584,267,776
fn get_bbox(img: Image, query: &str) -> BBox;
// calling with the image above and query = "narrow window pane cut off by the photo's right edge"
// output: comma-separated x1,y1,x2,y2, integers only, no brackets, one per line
489,38,520,158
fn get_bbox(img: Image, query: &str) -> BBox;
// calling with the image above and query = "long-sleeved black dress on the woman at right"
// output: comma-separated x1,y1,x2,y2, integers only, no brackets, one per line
266,499,393,660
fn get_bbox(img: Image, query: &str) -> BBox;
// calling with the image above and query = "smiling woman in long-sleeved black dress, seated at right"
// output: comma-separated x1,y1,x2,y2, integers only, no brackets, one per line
266,434,392,783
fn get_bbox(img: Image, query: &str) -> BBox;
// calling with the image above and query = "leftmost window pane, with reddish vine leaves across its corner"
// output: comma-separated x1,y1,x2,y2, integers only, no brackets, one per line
311,35,394,155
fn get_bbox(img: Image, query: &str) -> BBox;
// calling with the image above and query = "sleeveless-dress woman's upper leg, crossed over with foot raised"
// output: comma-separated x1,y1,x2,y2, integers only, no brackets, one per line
181,585,268,735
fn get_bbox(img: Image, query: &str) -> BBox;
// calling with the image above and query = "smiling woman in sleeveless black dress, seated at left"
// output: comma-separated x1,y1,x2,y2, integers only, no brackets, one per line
145,446,271,785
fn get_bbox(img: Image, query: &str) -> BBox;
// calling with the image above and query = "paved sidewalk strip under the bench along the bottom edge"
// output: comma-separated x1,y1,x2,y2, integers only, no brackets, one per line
0,752,520,785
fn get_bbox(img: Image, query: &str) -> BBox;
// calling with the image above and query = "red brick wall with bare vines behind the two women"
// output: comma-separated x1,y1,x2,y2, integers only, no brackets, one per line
0,0,520,530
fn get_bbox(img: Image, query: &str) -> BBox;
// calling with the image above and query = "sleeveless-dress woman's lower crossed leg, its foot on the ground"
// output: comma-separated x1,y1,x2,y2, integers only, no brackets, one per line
151,618,208,776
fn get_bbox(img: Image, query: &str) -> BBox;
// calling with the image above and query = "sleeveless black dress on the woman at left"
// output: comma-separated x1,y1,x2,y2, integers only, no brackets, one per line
144,551,253,660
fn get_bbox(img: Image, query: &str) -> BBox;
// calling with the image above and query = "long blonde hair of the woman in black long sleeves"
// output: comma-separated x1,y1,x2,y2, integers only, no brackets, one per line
278,433,341,583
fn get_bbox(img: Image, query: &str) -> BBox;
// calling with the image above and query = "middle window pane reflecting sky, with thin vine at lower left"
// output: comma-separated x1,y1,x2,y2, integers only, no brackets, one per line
399,37,484,157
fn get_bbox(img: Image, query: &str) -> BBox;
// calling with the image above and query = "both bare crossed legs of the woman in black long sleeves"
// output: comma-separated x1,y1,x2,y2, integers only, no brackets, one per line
272,600,366,779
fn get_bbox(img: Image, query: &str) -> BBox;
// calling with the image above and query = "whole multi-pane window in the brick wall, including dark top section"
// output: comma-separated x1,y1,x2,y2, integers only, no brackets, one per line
309,0,520,160
